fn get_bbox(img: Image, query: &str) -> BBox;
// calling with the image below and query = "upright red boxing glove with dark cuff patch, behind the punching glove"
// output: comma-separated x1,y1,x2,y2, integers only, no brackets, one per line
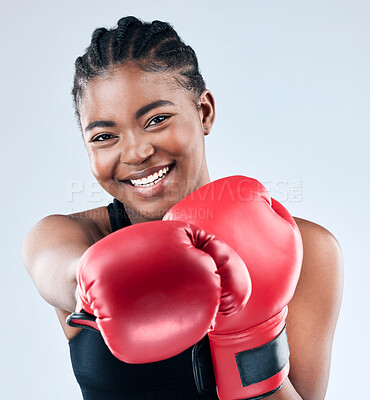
164,176,302,400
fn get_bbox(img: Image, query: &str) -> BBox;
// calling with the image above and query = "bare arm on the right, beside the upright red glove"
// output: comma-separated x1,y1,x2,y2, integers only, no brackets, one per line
268,218,343,400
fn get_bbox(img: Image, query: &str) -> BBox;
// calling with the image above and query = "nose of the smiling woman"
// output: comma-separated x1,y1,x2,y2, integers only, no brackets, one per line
120,134,155,165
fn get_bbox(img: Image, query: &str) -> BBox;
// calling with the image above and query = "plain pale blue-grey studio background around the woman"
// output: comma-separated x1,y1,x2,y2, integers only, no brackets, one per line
0,0,370,400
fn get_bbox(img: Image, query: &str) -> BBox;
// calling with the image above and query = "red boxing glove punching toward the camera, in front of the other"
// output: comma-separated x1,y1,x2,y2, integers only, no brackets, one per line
68,221,250,363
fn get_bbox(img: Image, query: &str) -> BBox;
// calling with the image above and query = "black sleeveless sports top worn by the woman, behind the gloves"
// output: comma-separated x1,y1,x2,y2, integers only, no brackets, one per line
69,199,218,400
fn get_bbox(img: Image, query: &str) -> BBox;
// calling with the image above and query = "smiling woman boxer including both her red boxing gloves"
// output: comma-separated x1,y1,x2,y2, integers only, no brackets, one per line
23,17,342,400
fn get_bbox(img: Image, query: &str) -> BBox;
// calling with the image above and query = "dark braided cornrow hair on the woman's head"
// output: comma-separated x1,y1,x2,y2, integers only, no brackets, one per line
72,16,205,117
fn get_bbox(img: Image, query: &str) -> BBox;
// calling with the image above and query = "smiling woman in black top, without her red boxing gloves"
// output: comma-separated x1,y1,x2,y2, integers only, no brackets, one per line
23,17,342,400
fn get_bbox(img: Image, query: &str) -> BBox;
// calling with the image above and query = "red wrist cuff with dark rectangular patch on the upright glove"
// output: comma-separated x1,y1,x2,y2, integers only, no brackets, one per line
208,307,289,400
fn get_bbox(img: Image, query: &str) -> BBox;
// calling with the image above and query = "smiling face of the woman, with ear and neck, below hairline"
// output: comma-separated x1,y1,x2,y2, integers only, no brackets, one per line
80,65,214,223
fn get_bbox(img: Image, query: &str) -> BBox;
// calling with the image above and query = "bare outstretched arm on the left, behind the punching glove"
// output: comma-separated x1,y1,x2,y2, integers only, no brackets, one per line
22,215,102,312
